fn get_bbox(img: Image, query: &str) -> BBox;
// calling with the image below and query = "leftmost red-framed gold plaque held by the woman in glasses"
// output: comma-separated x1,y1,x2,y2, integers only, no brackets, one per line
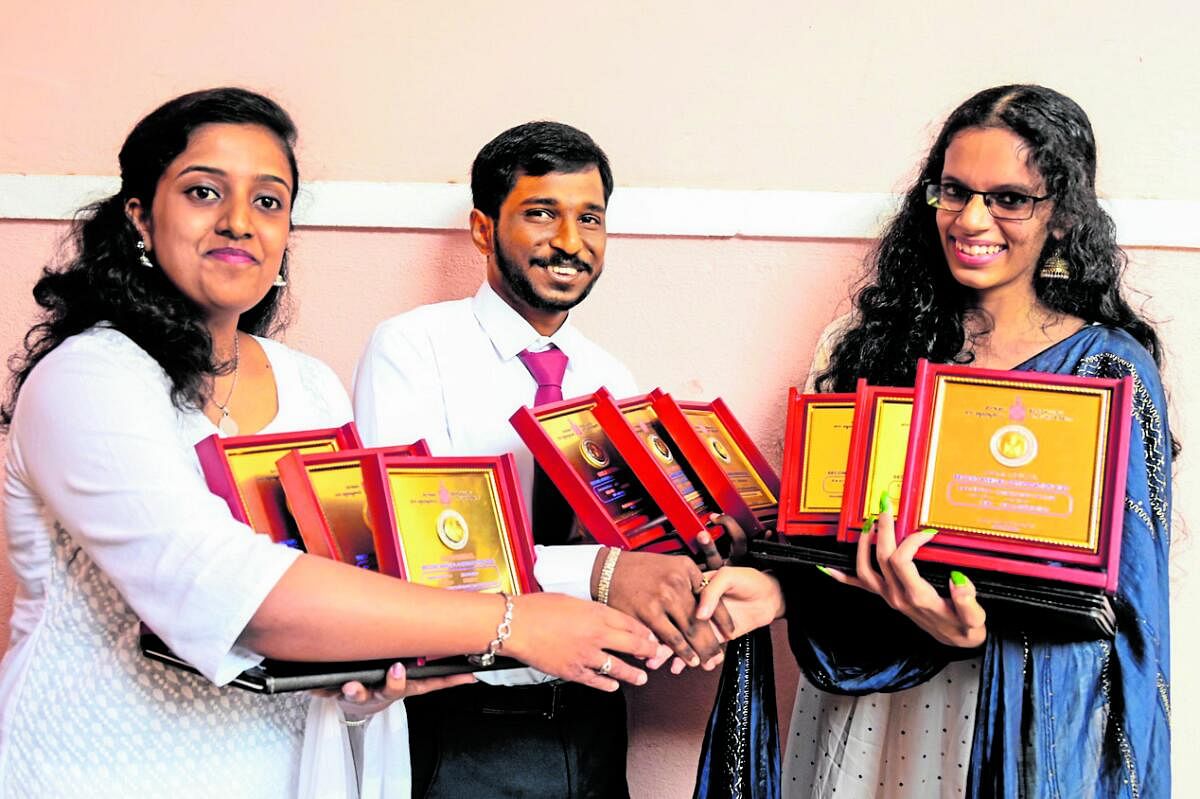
776,389,854,536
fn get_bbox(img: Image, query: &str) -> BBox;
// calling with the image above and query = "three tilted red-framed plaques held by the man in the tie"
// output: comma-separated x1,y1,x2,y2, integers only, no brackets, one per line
511,389,779,553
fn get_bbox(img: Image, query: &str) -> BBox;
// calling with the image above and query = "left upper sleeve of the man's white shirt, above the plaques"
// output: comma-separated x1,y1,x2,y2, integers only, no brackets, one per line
354,319,450,452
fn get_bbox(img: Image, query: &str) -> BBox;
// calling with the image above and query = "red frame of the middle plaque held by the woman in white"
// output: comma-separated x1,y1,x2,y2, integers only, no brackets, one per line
276,438,430,565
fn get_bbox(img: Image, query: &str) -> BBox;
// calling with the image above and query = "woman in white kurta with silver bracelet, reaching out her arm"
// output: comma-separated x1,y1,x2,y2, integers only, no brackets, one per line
0,89,658,798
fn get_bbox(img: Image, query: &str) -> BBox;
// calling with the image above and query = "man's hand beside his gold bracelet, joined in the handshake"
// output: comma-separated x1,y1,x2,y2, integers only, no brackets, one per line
593,552,733,669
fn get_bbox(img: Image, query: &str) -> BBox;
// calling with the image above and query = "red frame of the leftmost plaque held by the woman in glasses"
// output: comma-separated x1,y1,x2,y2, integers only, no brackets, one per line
776,388,854,536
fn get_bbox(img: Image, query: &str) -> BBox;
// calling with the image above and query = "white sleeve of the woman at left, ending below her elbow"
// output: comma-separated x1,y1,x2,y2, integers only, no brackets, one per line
10,343,299,684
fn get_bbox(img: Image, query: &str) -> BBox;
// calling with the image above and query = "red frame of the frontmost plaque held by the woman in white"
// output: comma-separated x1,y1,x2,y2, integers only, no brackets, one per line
361,451,540,594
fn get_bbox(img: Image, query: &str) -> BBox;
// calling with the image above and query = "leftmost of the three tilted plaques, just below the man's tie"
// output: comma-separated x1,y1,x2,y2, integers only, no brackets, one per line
509,395,698,552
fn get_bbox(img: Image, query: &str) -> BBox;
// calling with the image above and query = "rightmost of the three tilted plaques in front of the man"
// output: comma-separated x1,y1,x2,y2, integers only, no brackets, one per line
650,390,779,537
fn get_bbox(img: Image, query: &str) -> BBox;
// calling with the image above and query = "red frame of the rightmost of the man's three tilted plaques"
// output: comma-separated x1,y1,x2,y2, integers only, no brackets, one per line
649,389,780,537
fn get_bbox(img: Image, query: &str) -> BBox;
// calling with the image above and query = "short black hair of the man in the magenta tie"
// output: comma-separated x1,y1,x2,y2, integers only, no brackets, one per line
470,121,612,220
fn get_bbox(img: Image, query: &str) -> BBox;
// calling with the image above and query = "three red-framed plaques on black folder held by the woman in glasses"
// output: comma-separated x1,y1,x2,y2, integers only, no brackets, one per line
751,361,1132,639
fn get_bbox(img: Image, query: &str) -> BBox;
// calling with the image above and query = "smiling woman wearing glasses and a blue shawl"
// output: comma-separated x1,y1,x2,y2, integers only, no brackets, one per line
702,86,1174,799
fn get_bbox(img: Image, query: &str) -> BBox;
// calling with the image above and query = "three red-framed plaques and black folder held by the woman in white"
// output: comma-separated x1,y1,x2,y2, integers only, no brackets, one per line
140,423,528,693
